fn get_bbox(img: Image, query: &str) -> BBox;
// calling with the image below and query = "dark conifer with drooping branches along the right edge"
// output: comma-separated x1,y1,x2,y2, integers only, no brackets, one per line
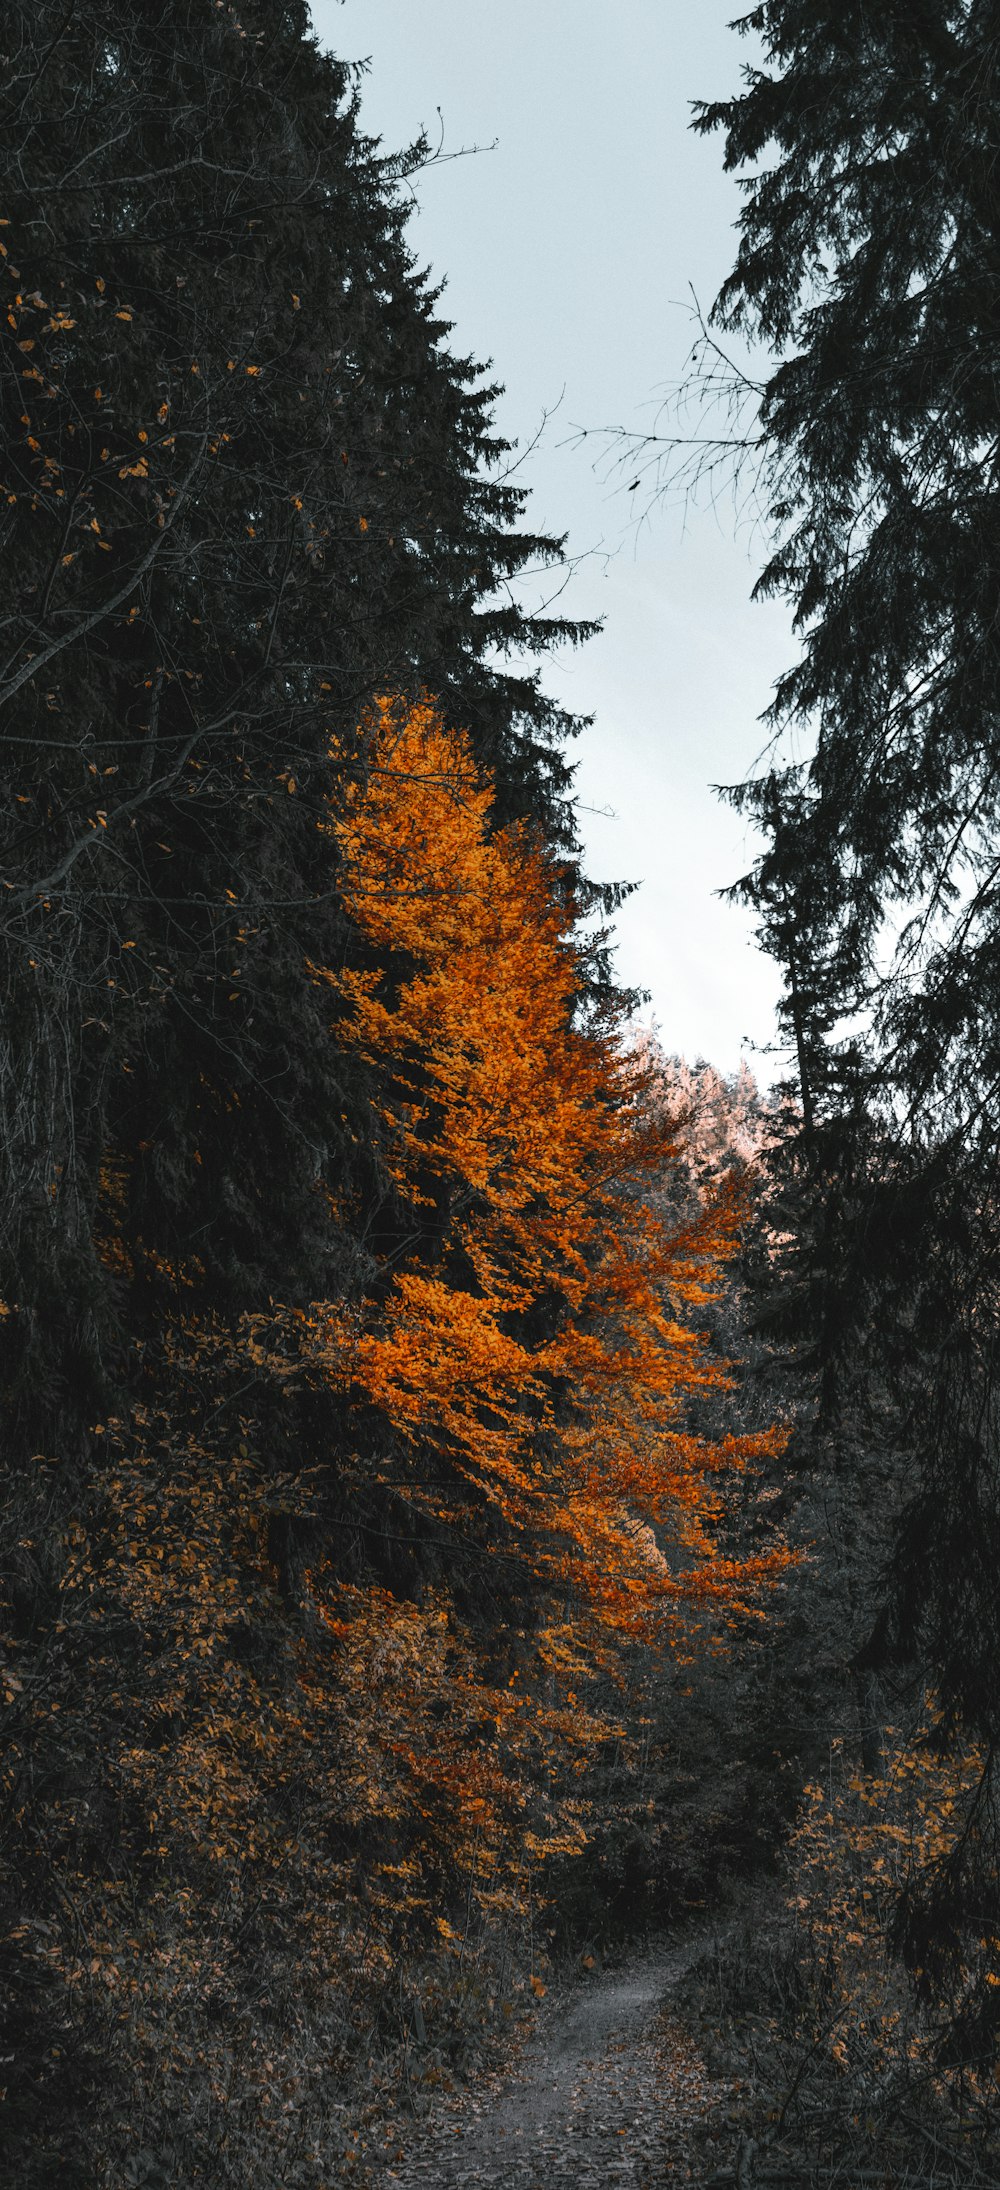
696,0,1000,2006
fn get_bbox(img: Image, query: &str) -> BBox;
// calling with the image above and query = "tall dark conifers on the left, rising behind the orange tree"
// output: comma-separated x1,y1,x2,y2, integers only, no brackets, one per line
0,0,580,1380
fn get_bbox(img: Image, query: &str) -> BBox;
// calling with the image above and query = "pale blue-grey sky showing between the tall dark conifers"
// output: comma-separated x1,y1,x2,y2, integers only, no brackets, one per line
313,0,794,1082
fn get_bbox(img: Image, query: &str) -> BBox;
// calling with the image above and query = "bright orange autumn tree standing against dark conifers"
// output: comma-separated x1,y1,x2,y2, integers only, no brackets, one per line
299,699,783,1813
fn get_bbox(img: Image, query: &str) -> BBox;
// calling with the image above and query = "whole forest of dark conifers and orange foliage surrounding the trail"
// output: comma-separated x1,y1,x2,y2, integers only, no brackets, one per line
0,0,1000,2190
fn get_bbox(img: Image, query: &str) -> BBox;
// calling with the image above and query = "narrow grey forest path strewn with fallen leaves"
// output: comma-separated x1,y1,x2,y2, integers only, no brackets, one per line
385,1932,729,2190
